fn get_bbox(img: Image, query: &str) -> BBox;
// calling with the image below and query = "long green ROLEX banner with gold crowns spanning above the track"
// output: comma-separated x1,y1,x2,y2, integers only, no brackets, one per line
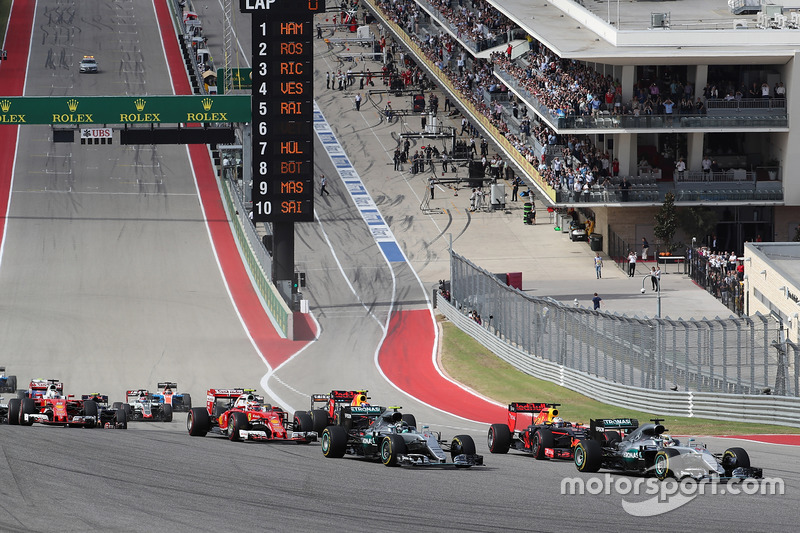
0,95,251,125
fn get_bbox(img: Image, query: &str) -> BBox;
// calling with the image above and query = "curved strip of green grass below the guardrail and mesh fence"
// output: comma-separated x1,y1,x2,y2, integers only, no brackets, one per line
441,319,800,435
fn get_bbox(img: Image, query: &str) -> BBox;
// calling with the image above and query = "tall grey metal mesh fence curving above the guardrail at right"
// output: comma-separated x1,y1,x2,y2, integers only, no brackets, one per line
449,252,800,396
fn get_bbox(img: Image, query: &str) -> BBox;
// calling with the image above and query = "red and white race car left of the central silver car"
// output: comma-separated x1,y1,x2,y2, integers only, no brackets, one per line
186,388,317,444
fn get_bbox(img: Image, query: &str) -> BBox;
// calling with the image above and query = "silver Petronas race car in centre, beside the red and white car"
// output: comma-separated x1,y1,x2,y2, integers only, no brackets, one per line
322,404,483,467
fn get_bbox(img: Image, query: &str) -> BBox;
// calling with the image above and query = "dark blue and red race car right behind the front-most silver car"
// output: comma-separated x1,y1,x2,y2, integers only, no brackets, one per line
487,402,588,459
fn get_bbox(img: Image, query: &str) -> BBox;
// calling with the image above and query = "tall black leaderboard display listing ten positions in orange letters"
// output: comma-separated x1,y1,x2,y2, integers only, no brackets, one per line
240,0,325,222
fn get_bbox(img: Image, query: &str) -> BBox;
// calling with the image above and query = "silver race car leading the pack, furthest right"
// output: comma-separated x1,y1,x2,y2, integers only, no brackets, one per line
575,418,762,480
